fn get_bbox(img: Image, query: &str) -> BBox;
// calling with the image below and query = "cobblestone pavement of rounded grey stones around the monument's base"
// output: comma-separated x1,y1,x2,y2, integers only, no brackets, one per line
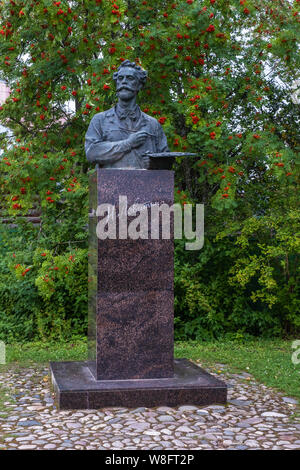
0,364,300,450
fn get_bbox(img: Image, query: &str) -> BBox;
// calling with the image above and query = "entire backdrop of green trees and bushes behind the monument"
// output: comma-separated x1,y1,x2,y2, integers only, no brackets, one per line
0,0,300,339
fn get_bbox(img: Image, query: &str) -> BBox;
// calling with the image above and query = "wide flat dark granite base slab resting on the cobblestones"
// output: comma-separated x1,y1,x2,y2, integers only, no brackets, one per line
50,359,227,410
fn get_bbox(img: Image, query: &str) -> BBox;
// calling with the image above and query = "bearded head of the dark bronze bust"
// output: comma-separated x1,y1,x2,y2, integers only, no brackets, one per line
113,60,147,100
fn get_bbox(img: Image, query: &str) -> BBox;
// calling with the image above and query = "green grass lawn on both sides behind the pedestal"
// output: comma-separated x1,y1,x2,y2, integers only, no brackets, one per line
0,338,300,401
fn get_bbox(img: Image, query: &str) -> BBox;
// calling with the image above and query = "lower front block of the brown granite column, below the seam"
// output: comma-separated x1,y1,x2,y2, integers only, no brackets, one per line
97,290,173,380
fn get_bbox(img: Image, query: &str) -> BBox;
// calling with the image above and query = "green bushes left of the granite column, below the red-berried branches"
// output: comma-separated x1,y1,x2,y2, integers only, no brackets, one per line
0,225,87,341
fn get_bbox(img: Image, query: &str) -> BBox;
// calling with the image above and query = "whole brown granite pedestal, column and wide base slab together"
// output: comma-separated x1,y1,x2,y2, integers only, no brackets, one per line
50,169,227,409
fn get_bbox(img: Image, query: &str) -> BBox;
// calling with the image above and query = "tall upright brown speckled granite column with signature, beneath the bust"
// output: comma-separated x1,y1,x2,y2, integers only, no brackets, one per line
89,169,174,380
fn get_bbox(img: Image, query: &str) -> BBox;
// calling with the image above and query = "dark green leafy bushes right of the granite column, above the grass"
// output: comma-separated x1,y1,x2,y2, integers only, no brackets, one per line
175,179,300,340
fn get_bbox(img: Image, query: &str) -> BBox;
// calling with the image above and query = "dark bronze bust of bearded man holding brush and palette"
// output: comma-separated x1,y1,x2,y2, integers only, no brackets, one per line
85,60,173,169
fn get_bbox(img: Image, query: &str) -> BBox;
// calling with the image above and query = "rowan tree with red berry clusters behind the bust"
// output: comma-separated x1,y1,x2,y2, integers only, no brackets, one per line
0,0,300,335
